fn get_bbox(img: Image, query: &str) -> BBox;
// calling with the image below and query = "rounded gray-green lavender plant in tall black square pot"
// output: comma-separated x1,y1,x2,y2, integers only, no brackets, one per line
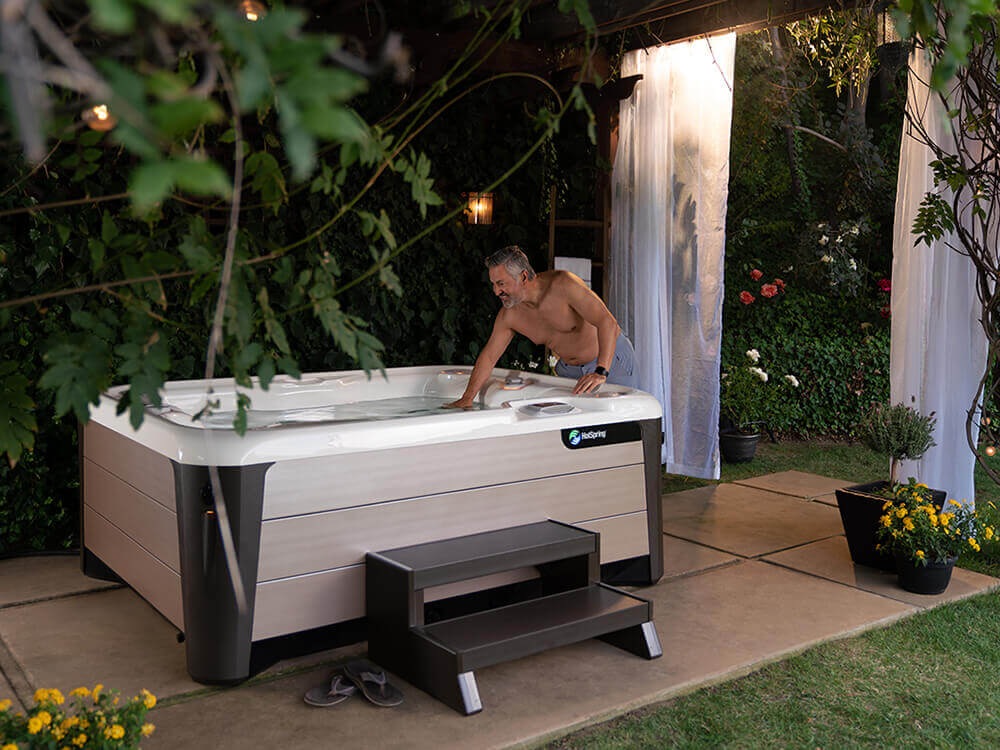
837,404,947,571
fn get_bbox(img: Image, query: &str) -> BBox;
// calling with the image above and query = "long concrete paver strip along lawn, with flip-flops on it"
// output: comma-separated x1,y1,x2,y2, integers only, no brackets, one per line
143,561,913,750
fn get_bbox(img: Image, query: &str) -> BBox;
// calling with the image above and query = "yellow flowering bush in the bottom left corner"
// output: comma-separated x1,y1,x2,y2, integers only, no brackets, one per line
0,685,156,750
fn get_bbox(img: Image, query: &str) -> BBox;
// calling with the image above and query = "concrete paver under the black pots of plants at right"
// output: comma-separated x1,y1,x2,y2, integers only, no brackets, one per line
763,536,1000,608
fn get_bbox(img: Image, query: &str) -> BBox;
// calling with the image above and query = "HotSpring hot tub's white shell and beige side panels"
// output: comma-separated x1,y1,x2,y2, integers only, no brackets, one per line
81,367,661,674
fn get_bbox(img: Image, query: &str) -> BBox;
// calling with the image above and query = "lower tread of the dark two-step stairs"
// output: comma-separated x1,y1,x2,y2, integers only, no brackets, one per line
413,583,652,671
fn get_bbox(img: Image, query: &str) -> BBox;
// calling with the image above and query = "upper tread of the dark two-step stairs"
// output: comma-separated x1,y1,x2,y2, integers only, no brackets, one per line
374,521,598,589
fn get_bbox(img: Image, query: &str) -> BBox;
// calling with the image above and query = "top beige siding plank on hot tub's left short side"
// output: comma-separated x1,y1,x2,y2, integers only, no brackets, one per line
83,424,177,510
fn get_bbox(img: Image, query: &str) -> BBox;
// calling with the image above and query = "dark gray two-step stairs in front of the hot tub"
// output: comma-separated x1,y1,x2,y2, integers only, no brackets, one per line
365,521,662,714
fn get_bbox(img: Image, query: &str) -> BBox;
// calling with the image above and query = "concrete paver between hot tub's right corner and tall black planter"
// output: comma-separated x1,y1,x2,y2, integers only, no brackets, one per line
663,484,843,557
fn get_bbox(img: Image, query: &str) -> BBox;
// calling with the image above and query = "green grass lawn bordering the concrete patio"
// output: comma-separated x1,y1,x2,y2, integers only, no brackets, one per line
550,442,1000,749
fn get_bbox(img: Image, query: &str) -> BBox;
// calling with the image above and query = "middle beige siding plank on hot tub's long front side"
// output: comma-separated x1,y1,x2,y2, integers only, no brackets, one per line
257,465,648,581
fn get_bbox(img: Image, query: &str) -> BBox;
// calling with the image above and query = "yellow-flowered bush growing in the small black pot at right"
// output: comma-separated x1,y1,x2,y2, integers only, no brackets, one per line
878,484,996,566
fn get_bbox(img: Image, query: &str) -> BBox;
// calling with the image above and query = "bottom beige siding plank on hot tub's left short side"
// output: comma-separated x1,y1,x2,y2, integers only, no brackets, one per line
83,505,184,630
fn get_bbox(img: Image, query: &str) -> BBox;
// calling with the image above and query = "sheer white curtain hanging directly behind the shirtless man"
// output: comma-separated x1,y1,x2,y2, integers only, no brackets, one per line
608,34,736,478
